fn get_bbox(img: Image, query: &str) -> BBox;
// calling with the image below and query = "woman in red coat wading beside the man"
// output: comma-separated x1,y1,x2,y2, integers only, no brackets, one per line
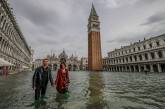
55,63,70,94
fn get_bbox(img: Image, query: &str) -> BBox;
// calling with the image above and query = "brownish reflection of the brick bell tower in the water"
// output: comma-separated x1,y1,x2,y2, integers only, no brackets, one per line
86,72,109,109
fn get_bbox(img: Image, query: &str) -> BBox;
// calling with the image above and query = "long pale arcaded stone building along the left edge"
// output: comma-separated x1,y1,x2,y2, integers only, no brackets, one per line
0,0,32,70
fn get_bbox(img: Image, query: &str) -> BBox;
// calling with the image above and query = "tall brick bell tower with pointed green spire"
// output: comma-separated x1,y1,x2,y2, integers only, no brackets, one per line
88,4,102,71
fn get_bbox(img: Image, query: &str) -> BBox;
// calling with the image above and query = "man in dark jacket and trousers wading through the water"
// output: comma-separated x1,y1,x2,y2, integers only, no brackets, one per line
32,59,54,101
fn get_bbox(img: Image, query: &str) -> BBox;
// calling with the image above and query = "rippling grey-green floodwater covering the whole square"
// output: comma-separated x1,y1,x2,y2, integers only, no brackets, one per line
0,71,165,109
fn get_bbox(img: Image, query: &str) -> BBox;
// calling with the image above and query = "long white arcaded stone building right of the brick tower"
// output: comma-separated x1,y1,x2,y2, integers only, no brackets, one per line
103,34,165,72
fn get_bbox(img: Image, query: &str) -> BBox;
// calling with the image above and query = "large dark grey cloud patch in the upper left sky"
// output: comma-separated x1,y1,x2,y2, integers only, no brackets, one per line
10,0,58,26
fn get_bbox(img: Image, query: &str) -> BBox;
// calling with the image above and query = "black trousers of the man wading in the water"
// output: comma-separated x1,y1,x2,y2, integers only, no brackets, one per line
35,85,47,100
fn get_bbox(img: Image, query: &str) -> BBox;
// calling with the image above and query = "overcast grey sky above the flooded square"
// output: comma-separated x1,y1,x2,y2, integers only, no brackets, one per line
9,0,165,58
